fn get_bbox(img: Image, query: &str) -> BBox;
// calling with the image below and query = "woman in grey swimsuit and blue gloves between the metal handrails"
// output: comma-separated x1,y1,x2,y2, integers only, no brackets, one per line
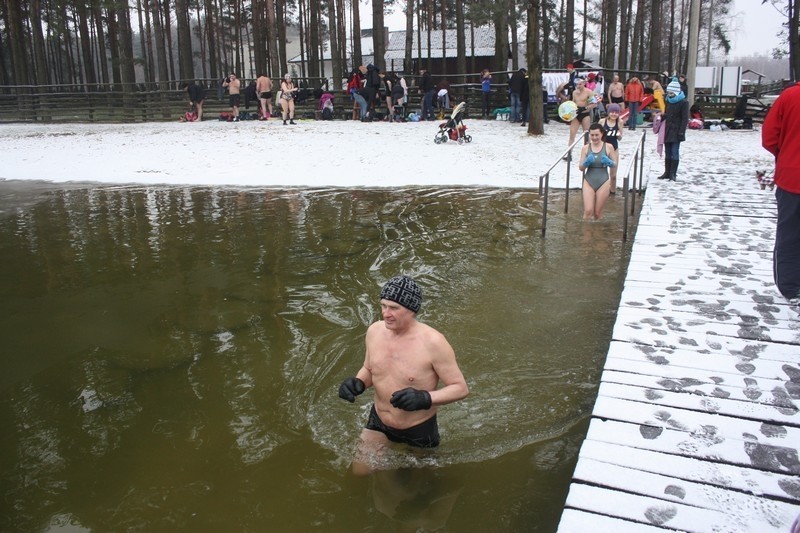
578,122,616,220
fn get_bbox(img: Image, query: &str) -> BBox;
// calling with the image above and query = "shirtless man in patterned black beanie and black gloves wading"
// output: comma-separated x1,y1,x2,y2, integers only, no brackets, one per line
339,276,469,474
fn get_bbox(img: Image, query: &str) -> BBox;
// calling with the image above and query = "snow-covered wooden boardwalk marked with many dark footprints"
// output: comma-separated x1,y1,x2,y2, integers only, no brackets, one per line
559,153,800,533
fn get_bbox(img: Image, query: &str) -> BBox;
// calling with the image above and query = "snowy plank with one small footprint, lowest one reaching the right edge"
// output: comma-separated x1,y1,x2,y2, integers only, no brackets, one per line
573,457,800,531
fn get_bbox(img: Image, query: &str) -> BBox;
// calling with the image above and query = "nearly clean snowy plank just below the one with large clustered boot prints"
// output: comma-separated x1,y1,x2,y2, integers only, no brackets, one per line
580,440,800,500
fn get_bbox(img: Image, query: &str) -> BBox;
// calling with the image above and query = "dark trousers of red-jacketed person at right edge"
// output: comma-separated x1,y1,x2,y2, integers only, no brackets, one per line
772,187,800,298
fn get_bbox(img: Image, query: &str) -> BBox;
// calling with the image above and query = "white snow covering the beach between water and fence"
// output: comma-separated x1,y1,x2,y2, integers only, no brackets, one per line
0,119,772,188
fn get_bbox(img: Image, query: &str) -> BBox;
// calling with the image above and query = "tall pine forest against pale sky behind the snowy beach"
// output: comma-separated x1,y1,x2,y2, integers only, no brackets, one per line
0,0,800,90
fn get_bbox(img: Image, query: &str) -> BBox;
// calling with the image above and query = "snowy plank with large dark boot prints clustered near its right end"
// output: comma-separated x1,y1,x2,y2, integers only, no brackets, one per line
586,414,800,476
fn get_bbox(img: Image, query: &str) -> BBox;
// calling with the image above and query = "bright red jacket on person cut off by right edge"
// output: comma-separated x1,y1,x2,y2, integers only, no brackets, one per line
761,82,800,194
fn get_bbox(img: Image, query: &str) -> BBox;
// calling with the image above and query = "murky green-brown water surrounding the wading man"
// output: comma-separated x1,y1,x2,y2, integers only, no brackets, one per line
0,183,628,531
